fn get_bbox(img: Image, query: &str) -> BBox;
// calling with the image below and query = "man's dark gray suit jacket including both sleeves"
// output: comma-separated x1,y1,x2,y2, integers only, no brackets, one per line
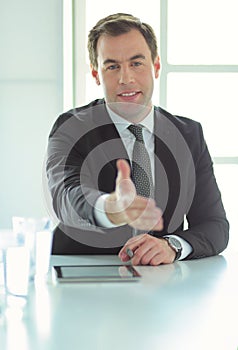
47,100,229,258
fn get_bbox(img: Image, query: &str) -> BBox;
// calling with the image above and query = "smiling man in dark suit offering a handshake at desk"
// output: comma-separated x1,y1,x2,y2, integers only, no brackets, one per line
47,14,229,265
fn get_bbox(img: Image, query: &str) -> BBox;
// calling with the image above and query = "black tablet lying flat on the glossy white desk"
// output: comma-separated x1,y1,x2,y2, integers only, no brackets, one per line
53,265,141,282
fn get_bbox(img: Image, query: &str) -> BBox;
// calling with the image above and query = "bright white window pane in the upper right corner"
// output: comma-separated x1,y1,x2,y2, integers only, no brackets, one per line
168,0,238,65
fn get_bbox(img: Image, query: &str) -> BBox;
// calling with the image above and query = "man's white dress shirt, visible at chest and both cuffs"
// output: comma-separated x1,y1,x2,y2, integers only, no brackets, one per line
94,105,192,260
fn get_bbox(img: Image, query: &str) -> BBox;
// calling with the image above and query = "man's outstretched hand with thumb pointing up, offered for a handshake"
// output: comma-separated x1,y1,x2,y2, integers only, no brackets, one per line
105,159,163,231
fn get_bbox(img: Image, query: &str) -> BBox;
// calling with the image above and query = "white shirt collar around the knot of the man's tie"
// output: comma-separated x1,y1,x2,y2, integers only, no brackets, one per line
106,104,154,134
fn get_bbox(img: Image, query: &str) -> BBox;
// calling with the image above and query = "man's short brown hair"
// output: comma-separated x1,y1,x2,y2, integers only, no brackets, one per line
88,13,158,69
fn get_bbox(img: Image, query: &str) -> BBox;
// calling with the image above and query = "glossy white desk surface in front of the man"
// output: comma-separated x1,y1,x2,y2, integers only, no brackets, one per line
0,255,238,350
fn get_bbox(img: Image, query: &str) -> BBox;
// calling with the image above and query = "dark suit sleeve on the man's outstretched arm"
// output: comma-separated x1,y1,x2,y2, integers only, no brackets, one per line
46,115,101,230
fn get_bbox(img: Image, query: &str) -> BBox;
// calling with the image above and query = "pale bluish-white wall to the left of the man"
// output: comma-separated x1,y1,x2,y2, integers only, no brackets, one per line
0,0,63,229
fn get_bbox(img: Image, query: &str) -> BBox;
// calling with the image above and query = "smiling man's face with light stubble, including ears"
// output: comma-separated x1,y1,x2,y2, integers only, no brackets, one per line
92,29,160,121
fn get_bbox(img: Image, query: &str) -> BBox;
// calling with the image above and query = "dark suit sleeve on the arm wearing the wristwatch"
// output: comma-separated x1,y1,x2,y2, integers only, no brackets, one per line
176,124,229,259
